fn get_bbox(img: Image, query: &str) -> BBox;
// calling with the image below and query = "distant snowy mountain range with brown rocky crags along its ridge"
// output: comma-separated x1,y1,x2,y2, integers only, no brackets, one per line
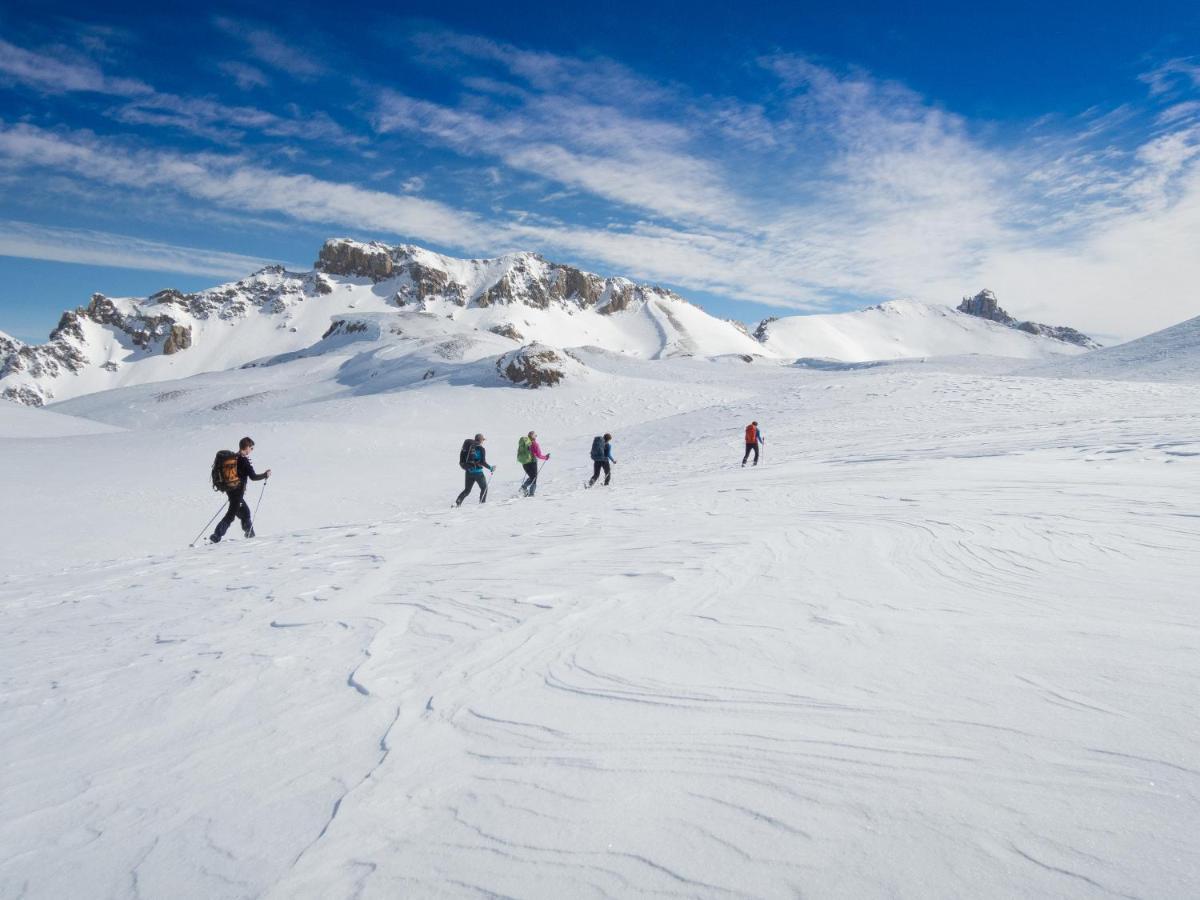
0,239,1096,406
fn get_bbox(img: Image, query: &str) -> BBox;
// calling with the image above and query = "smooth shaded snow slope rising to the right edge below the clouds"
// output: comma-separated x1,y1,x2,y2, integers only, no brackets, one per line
1031,316,1200,382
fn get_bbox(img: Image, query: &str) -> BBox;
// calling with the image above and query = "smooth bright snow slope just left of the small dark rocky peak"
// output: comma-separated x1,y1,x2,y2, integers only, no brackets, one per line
756,300,1082,362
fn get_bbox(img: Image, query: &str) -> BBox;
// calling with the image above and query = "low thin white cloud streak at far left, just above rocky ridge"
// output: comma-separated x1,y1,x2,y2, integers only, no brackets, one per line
0,221,284,278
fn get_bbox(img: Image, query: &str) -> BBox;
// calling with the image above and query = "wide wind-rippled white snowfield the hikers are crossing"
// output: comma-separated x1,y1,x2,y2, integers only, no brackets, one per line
0,332,1200,898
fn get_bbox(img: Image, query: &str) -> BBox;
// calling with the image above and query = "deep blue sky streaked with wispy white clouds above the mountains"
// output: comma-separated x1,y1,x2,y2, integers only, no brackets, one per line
0,0,1200,340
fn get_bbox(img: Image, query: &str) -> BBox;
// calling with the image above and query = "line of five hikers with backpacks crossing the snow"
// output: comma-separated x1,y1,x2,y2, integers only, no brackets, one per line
200,421,766,544
